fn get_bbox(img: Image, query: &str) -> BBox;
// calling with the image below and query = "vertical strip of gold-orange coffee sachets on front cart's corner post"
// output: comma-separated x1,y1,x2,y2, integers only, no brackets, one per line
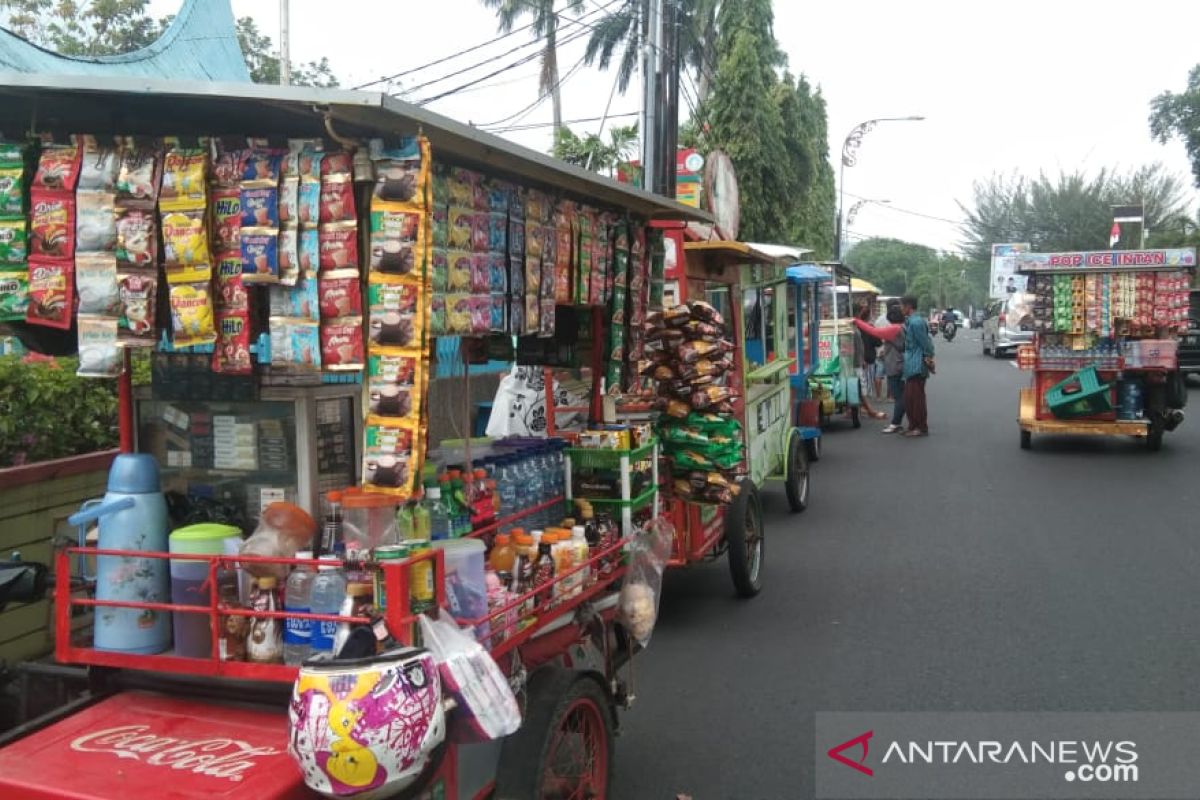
364,138,432,498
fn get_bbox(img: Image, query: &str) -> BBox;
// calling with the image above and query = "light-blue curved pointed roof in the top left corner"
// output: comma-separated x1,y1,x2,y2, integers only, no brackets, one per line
0,0,250,83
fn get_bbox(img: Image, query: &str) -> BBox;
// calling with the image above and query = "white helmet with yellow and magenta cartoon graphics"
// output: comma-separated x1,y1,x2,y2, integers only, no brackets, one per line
288,648,445,800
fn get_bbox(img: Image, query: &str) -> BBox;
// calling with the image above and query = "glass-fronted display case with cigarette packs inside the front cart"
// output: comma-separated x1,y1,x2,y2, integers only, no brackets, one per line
137,384,361,529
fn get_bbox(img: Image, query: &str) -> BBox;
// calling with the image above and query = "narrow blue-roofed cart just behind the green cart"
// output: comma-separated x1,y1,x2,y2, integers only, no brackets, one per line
787,264,833,462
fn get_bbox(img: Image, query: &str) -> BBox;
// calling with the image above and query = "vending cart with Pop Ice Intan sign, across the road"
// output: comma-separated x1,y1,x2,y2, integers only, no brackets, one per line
1016,248,1196,450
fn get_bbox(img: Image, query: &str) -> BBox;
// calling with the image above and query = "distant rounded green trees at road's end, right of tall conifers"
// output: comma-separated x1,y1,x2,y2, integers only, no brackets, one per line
846,239,989,308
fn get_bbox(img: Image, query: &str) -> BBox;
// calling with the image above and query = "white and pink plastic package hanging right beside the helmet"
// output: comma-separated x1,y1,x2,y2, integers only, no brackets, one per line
419,609,521,742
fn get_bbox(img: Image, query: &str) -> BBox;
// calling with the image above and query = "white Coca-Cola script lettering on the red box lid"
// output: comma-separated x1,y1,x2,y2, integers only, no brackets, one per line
71,724,284,781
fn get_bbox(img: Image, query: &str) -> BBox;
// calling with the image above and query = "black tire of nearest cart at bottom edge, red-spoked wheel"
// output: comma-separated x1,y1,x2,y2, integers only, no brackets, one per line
492,667,617,800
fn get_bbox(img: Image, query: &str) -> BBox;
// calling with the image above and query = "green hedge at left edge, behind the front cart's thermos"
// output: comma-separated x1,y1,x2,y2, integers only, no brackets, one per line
0,356,118,468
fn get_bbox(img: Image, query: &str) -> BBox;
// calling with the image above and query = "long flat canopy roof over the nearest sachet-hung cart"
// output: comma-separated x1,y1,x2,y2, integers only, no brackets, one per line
0,73,712,221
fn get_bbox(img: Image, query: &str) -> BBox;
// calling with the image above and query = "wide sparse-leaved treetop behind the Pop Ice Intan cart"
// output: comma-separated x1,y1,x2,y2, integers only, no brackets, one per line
960,164,1189,261
